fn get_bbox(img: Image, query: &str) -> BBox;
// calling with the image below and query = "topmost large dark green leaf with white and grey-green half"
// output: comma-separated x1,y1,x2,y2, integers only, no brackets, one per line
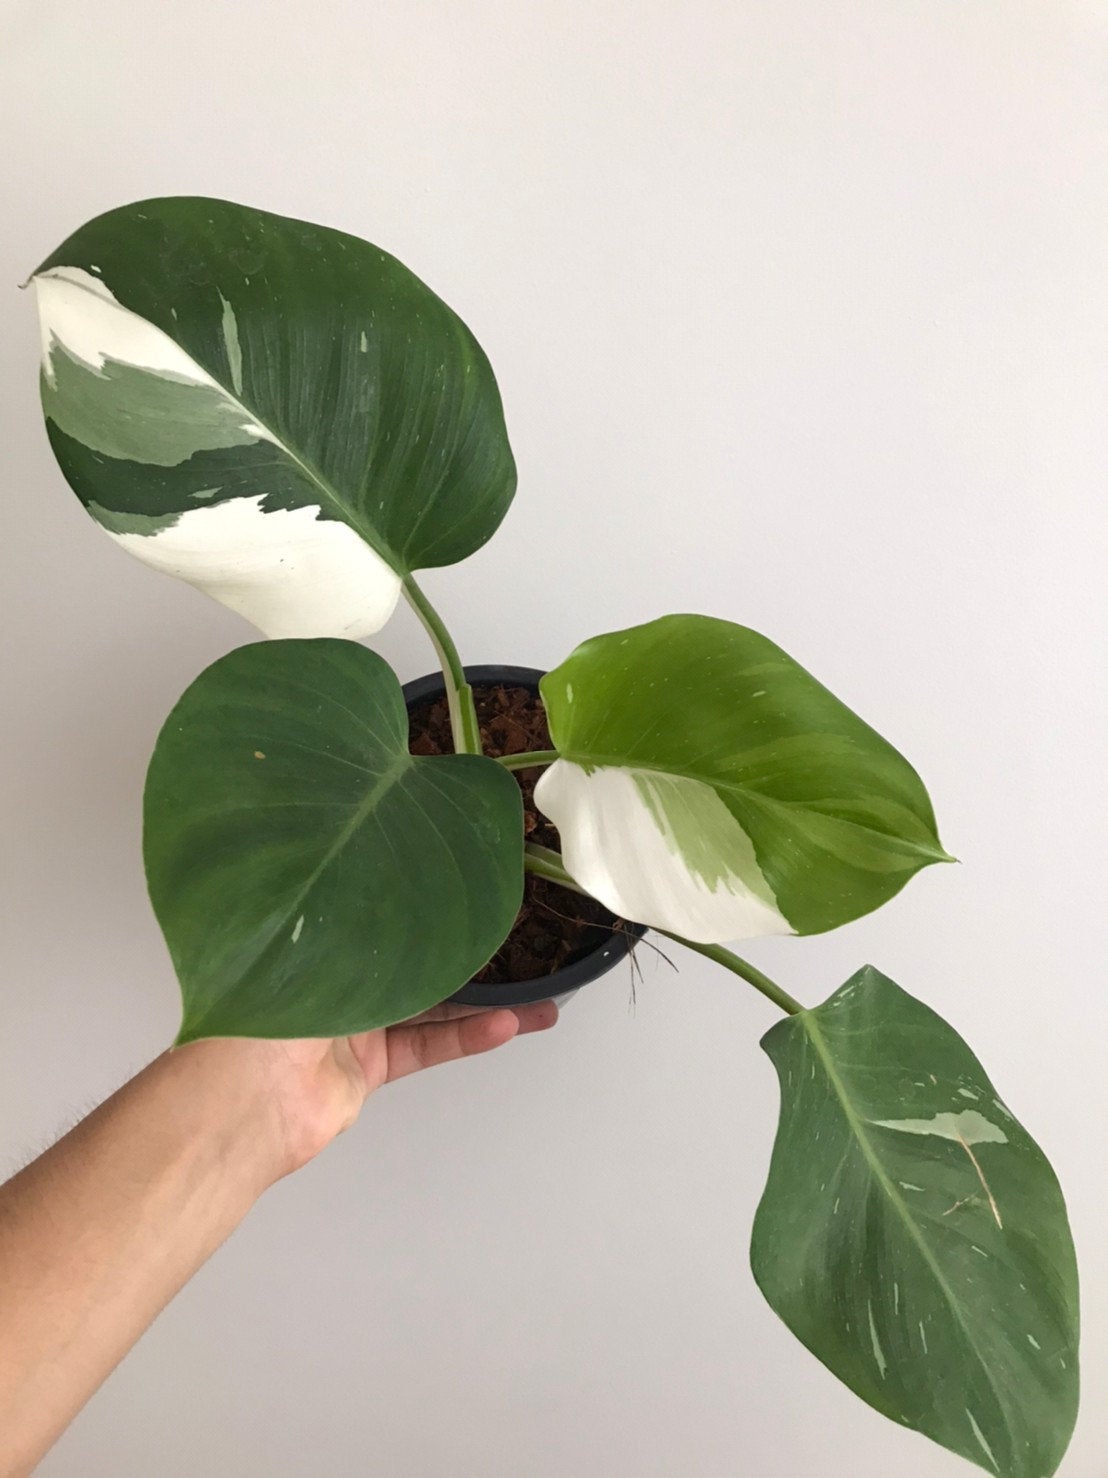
33,197,516,637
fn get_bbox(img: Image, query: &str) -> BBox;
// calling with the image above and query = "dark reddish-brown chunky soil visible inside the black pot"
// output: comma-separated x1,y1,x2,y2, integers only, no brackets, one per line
409,684,612,986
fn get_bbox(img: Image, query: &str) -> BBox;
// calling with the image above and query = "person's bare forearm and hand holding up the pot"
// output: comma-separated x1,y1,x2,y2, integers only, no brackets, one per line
0,1001,558,1478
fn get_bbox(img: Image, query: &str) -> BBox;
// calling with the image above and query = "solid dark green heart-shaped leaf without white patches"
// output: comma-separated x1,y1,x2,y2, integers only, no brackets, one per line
145,638,523,1041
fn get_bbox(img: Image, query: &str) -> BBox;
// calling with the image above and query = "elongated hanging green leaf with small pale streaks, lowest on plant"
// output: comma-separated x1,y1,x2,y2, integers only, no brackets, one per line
750,967,1078,1478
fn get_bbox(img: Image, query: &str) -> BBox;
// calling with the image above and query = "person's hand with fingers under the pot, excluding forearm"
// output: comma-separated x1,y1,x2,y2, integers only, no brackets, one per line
173,1001,558,1179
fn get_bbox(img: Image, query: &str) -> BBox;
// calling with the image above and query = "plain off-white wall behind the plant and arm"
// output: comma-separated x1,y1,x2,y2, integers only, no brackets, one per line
0,0,1108,1478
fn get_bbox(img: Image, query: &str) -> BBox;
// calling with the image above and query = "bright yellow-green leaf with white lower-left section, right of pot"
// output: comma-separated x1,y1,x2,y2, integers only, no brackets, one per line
535,616,950,943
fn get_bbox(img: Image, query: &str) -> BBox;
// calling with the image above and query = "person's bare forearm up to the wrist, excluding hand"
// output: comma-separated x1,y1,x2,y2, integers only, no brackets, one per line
0,1042,291,1478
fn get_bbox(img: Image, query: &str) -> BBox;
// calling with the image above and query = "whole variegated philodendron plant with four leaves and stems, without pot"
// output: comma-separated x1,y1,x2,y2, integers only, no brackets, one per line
33,198,1077,1478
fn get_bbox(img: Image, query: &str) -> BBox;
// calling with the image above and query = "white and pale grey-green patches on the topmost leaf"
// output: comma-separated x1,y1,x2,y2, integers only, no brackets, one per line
34,268,400,638
